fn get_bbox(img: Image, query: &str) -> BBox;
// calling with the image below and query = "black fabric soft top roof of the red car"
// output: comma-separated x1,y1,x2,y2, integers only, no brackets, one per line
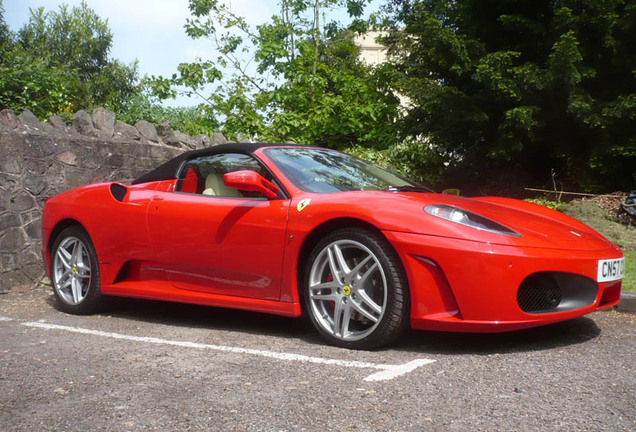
132,143,288,184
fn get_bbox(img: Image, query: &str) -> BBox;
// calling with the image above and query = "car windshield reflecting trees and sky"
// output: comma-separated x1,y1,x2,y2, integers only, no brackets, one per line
265,147,429,193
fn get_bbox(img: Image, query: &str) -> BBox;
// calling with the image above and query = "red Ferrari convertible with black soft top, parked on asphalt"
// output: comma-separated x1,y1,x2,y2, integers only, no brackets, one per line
42,144,625,349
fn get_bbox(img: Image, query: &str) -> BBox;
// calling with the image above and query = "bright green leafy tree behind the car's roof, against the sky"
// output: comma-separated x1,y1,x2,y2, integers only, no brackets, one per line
153,0,398,147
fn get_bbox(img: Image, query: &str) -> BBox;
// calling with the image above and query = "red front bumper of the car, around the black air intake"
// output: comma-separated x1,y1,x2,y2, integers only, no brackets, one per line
384,231,622,332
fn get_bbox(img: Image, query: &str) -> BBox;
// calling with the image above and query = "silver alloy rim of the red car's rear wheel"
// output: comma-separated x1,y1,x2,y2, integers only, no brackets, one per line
53,237,91,305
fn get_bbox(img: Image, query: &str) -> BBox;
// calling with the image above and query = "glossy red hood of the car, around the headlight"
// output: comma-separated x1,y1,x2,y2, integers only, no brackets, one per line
306,191,613,251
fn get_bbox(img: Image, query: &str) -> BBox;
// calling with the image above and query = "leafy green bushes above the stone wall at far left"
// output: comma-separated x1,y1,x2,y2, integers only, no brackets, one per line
0,2,140,118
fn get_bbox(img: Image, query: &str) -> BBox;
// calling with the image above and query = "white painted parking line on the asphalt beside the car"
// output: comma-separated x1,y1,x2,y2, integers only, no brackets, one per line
22,322,435,381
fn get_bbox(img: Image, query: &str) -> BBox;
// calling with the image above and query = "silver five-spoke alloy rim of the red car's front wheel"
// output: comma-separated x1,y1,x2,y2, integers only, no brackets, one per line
309,240,388,341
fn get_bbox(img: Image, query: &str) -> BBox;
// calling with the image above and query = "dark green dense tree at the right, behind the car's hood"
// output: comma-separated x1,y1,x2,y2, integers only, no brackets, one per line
385,0,636,190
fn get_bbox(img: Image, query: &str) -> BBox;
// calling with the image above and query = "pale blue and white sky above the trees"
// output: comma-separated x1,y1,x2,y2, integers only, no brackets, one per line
4,0,380,105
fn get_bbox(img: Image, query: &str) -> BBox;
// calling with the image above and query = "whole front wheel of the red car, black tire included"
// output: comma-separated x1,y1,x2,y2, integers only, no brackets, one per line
301,228,410,349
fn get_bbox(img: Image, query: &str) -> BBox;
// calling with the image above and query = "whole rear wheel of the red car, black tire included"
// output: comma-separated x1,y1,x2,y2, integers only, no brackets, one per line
51,226,104,315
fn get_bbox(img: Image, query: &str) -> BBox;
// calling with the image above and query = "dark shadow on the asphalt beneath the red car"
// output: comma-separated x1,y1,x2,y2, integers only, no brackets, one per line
47,295,601,355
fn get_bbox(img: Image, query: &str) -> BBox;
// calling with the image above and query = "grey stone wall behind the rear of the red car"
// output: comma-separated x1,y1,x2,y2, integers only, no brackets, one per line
0,108,225,293
